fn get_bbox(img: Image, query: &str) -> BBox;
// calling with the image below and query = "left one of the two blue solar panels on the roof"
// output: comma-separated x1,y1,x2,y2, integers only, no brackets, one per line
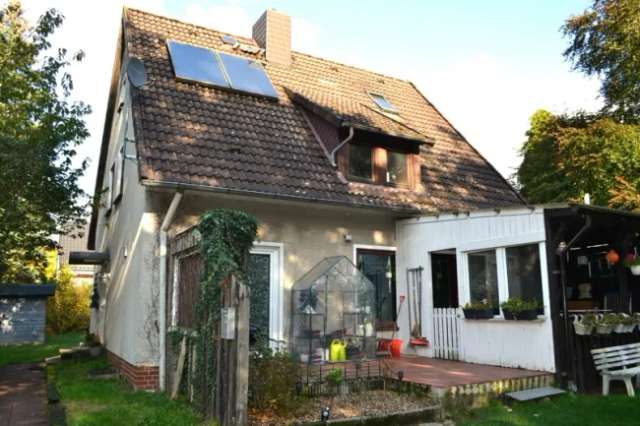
167,40,230,87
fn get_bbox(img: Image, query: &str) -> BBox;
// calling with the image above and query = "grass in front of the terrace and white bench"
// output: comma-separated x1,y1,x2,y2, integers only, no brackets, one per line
456,394,640,426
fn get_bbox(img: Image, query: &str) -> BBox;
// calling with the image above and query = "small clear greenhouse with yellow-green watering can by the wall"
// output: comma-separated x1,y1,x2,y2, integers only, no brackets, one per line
291,256,376,364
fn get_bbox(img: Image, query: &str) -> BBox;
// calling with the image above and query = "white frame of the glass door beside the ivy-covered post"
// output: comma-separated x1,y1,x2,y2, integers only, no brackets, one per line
249,241,287,350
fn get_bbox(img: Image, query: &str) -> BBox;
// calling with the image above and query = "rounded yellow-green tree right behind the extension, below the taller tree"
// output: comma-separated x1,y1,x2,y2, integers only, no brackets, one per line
516,110,640,210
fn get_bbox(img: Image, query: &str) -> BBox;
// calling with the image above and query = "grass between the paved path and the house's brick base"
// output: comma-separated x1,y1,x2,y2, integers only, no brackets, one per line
48,358,208,426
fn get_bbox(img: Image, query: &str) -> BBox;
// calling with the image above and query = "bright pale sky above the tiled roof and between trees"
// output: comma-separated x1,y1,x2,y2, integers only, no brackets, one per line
22,0,600,193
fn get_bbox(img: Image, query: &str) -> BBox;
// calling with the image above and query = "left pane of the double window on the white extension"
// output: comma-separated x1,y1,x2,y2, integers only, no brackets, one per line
467,250,500,314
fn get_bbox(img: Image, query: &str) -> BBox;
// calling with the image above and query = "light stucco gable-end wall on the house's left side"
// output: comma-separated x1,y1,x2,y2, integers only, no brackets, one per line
95,76,159,365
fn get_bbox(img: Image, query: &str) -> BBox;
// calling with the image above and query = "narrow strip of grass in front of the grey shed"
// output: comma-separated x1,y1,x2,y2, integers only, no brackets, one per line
0,333,84,367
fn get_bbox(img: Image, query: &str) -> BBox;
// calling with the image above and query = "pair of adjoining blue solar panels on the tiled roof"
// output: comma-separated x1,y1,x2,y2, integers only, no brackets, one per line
167,40,278,99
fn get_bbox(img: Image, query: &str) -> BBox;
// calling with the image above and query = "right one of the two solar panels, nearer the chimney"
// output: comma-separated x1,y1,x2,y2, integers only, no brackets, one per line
218,52,278,98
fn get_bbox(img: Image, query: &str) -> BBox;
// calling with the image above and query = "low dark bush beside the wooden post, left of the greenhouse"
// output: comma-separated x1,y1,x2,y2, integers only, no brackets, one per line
249,348,300,415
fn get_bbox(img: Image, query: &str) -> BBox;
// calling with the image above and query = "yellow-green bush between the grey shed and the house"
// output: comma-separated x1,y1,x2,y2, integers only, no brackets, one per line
47,267,91,334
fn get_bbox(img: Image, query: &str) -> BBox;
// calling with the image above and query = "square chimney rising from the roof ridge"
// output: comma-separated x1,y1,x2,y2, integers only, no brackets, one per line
253,9,291,65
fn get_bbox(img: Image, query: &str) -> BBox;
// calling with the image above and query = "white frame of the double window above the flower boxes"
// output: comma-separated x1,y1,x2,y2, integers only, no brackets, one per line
461,241,549,318
